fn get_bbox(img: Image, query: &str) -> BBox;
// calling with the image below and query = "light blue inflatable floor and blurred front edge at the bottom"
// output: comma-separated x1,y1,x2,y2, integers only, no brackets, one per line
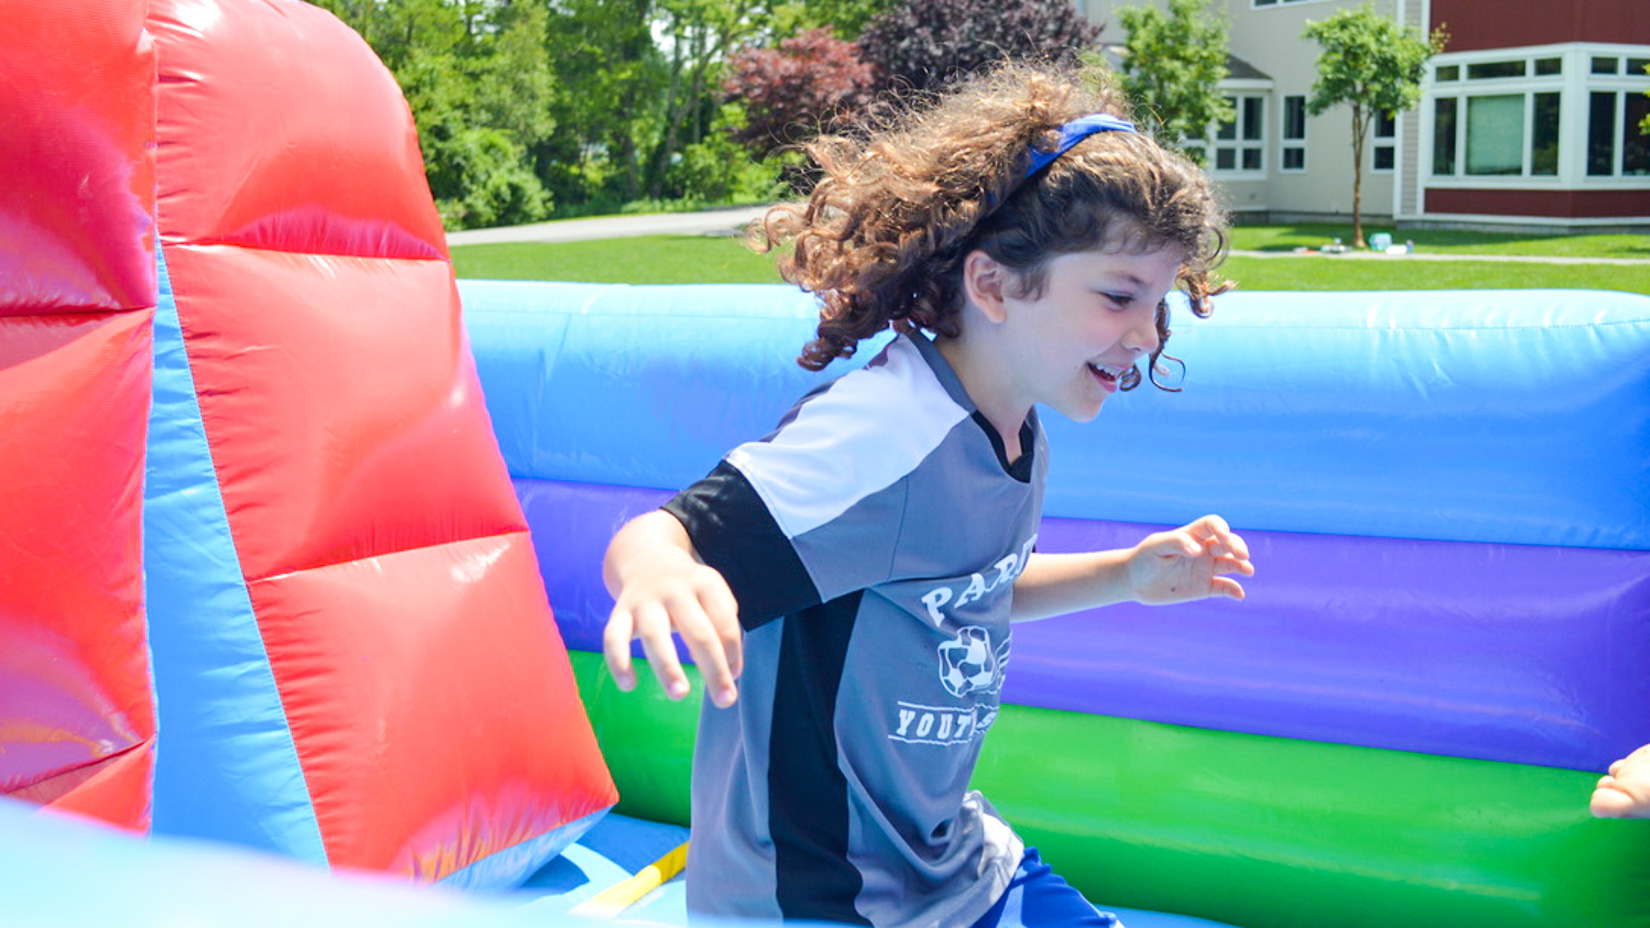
0,799,1216,928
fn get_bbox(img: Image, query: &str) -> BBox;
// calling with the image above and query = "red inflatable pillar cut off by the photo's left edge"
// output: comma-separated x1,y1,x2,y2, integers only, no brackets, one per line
0,0,155,829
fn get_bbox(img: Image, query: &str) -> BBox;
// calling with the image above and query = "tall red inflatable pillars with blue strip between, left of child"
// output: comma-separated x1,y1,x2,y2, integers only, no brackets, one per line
0,0,615,887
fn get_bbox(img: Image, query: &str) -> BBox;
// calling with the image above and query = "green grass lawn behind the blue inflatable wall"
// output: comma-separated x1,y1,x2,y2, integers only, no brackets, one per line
452,226,1650,294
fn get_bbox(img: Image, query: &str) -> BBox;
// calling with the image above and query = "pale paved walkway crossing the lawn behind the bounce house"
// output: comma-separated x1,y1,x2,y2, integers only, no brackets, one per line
447,206,1650,266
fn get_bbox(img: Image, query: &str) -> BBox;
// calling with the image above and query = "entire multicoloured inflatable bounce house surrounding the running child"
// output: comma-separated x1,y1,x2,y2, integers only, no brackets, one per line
0,0,1650,928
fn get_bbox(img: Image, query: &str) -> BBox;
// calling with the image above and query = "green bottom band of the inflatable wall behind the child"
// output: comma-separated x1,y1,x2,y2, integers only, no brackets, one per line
573,651,1650,928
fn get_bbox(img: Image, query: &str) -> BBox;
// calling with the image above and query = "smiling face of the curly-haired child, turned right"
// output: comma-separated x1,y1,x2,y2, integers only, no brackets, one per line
1002,244,1185,423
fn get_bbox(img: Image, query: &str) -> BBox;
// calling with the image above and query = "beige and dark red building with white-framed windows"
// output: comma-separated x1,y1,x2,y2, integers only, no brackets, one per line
1076,0,1650,231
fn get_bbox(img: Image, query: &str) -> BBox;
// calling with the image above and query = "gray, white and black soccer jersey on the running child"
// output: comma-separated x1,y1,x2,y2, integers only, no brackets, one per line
665,328,1048,928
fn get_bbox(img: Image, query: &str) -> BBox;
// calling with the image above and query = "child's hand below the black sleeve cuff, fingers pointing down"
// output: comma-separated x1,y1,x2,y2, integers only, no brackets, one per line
602,510,743,708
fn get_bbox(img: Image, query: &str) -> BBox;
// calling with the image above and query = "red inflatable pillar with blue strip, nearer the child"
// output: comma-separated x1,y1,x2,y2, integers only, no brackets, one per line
145,0,615,885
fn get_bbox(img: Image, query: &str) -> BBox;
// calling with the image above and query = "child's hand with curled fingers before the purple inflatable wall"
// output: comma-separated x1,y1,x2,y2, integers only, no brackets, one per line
1129,515,1254,604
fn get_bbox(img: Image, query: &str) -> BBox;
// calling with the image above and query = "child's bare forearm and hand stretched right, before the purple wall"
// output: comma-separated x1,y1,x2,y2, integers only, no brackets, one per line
1013,515,1254,623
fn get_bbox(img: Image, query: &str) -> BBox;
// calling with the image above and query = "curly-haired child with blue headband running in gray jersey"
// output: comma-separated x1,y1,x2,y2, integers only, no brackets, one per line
604,64,1254,928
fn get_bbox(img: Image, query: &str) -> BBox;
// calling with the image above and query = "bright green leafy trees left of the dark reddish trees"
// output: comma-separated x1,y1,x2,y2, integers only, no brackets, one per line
314,0,894,216
